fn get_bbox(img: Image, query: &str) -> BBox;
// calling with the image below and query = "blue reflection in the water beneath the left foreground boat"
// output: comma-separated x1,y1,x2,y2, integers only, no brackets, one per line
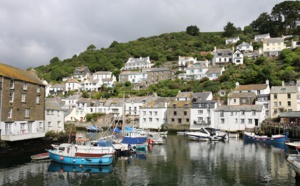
48,162,113,174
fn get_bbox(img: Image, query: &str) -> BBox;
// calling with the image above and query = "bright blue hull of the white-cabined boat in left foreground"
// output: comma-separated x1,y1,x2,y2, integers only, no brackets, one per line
48,150,114,165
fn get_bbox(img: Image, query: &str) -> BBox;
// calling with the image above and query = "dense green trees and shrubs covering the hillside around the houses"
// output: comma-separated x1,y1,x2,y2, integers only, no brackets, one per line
35,1,300,99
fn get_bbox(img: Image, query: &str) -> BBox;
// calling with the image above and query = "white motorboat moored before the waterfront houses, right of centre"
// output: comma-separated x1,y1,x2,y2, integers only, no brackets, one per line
185,128,226,141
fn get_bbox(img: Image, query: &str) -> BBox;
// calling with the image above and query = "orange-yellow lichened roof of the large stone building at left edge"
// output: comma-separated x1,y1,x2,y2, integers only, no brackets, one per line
0,63,45,86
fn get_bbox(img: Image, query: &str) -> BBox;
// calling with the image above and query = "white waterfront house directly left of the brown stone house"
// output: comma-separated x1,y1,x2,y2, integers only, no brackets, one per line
139,97,174,129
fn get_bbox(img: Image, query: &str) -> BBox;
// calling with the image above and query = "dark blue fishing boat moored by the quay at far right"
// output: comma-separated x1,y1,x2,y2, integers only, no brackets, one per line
243,132,288,143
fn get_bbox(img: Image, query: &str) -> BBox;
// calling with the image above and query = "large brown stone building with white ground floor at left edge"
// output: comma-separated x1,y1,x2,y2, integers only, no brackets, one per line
0,64,45,141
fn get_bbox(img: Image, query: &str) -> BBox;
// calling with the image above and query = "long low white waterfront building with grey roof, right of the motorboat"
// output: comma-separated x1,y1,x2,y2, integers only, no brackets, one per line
214,105,265,132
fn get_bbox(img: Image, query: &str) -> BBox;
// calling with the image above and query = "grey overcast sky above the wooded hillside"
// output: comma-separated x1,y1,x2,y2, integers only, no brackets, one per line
0,0,283,69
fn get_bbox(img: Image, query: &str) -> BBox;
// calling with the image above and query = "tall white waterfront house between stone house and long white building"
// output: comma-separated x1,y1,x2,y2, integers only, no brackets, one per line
190,92,217,129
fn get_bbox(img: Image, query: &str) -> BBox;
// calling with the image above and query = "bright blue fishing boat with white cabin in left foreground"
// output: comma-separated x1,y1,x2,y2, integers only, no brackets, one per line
47,143,114,165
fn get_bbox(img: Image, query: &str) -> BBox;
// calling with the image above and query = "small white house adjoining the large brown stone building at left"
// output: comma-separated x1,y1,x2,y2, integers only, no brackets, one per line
45,99,65,132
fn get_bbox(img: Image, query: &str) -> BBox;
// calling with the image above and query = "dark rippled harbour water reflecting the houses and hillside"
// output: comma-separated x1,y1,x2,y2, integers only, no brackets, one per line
0,134,300,186
